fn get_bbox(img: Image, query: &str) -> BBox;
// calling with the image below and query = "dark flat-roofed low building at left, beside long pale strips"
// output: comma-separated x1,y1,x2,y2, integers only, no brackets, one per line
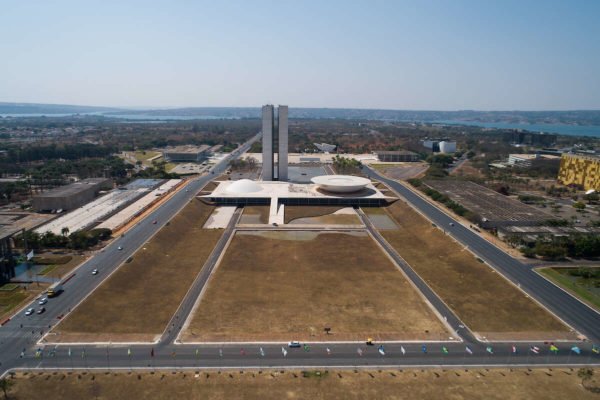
32,178,112,211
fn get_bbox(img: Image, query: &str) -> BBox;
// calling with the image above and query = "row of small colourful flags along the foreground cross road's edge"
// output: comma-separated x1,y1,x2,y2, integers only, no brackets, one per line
32,343,600,358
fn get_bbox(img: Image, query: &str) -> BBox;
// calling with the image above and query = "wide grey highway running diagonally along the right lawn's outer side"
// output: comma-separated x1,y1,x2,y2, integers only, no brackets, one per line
365,167,600,343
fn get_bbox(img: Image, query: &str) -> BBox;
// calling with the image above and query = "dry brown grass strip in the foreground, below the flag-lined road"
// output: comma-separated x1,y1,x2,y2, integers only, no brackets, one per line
9,368,600,400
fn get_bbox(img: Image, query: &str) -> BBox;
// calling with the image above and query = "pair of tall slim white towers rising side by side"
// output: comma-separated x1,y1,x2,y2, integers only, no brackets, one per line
262,104,288,181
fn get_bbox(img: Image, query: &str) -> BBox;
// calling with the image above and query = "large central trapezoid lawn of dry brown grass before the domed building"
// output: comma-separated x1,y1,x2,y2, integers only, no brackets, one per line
183,231,449,342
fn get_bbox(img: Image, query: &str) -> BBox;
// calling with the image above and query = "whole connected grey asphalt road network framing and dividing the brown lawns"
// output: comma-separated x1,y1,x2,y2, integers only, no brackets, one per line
0,146,600,373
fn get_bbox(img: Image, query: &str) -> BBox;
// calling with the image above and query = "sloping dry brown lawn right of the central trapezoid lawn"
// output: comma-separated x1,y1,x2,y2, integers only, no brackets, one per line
365,201,568,339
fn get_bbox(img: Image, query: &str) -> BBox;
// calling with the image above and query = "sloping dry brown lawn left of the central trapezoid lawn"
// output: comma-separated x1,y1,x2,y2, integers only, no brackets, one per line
49,199,223,341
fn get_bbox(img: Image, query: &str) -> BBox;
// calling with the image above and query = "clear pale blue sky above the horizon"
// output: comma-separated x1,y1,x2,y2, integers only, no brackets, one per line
0,0,600,110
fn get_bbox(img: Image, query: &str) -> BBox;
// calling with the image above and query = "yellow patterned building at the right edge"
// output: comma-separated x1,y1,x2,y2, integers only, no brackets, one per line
558,153,600,190
